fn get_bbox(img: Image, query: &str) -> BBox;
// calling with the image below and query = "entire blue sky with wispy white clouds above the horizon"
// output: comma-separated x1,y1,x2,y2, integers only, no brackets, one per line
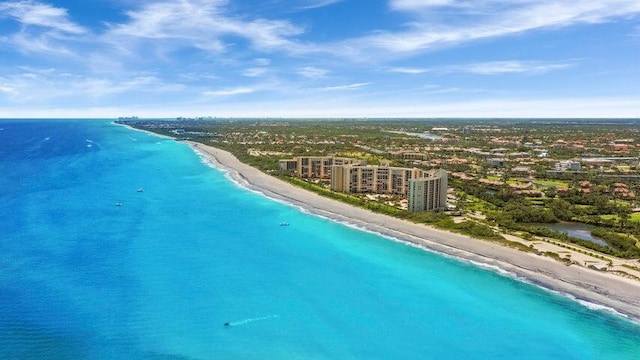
0,0,640,118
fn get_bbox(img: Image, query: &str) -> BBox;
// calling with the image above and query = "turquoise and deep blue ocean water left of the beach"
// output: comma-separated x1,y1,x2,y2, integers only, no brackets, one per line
0,121,640,359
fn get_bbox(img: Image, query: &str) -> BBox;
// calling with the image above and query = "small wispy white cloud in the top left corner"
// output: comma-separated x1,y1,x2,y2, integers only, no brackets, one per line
0,1,86,34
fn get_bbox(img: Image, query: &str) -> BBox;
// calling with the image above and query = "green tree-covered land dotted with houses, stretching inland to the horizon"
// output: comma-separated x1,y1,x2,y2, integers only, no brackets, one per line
119,119,640,258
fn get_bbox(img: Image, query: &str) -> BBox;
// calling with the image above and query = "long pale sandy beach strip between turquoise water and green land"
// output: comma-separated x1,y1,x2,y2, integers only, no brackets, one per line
187,142,640,321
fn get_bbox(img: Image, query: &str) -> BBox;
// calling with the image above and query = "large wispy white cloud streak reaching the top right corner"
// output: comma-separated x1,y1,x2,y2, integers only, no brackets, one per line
339,0,640,57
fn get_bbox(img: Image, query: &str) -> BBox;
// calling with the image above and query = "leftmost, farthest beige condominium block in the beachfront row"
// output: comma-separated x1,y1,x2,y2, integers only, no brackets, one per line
279,156,367,179
